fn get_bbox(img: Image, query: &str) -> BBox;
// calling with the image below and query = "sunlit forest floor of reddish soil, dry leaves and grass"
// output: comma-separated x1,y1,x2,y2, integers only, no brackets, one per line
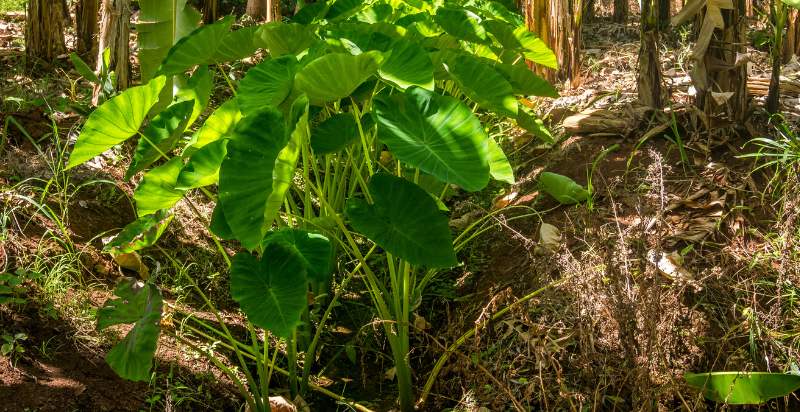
0,7,800,411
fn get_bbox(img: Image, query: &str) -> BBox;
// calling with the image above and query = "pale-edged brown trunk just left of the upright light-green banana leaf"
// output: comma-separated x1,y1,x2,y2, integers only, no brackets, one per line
95,0,131,99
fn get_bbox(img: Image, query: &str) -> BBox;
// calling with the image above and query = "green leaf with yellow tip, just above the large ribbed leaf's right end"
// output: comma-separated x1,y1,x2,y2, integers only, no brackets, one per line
447,55,518,117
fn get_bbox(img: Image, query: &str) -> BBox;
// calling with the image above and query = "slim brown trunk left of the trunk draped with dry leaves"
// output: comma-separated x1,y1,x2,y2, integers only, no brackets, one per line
636,0,669,109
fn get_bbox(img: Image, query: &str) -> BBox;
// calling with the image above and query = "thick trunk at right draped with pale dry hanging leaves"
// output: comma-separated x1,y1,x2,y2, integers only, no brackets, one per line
686,0,750,128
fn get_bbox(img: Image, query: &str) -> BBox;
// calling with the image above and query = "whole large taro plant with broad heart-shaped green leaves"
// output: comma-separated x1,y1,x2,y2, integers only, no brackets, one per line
68,0,558,411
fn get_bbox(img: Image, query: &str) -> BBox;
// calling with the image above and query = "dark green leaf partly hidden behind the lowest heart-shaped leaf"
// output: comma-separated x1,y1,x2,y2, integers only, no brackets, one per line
262,229,333,283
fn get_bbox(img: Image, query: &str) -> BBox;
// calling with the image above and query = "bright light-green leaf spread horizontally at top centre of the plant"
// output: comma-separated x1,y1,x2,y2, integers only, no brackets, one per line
295,51,383,105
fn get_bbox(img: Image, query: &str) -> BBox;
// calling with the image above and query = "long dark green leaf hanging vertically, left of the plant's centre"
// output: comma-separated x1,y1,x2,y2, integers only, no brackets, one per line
219,107,287,249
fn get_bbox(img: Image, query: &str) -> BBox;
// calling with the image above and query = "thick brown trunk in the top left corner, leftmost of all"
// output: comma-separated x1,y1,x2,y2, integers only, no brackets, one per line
25,0,67,63
